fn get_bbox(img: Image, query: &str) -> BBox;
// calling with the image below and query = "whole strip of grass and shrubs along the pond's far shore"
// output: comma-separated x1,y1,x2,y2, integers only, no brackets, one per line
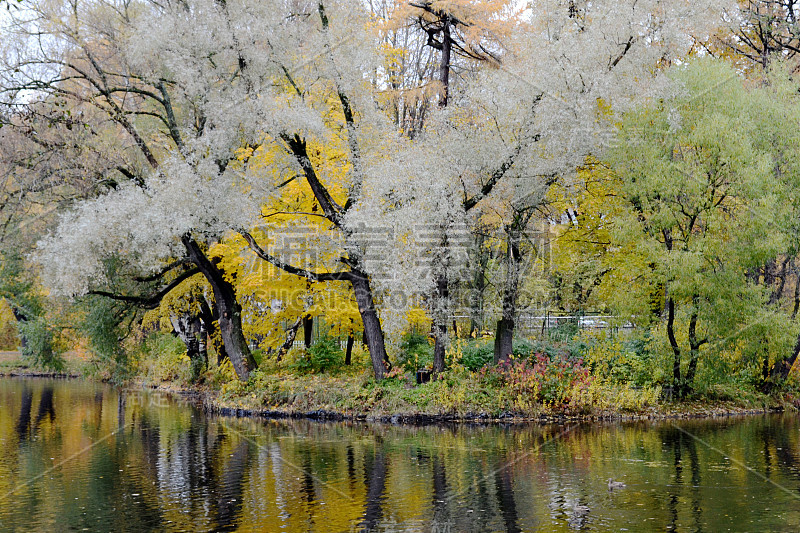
6,334,800,420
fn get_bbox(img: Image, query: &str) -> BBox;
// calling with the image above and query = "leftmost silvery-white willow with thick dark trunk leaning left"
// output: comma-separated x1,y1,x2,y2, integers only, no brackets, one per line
0,0,282,379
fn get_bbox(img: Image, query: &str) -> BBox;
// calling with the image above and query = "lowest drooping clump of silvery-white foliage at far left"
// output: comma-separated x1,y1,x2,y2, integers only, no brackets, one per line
34,153,264,296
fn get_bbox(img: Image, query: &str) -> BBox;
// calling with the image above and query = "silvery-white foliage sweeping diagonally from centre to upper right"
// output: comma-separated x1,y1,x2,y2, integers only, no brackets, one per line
342,0,735,329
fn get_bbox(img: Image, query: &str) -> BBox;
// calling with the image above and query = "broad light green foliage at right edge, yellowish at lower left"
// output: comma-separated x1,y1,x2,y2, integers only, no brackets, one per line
601,59,797,389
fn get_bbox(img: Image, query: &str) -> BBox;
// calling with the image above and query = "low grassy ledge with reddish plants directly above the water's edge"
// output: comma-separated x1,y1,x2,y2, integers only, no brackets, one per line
198,364,795,420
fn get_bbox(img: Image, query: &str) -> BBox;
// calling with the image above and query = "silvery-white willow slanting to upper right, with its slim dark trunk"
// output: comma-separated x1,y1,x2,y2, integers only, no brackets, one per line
362,1,722,368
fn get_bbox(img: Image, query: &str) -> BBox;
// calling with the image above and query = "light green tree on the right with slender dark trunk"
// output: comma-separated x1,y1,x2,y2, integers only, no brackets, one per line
607,61,784,397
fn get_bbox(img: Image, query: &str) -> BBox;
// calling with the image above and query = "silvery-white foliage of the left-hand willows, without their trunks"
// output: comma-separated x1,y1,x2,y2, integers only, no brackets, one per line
23,0,381,294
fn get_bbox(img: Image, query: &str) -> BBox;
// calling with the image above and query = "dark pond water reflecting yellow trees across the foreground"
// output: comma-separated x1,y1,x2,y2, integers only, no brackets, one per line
0,378,800,533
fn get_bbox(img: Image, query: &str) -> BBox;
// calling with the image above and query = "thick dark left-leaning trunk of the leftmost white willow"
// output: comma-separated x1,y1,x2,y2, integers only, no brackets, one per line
181,235,256,381
